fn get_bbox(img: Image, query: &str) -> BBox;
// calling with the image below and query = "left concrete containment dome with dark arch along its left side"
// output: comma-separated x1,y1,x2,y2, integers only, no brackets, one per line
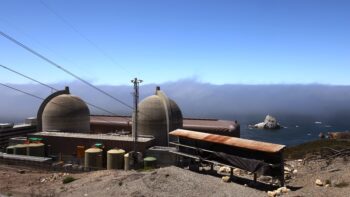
41,94,90,133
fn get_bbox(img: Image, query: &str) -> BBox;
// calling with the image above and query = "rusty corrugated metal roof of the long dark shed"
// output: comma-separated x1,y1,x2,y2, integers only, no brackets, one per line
169,129,285,153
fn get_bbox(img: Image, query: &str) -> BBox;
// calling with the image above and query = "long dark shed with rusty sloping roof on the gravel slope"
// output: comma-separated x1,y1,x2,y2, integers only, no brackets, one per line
169,129,285,185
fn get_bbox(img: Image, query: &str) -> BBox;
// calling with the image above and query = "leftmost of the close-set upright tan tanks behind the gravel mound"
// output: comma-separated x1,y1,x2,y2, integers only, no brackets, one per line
85,148,103,170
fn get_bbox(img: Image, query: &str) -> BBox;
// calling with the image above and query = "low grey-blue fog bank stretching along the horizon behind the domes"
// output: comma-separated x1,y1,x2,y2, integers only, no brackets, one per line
0,80,350,124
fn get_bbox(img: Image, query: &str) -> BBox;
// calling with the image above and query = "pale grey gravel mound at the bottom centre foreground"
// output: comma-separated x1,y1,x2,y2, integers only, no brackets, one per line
56,167,265,197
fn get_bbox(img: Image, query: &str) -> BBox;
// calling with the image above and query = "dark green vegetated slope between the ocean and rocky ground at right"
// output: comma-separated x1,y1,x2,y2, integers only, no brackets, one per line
284,139,350,160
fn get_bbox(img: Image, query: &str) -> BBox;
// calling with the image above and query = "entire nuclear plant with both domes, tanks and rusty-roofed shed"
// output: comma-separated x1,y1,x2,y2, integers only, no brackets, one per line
0,87,284,184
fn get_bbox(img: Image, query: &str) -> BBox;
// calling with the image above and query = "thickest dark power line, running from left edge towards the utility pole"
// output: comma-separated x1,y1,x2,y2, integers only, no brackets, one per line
0,31,133,109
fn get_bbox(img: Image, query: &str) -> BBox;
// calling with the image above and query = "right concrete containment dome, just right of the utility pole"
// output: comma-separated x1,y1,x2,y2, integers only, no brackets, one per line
138,87,183,146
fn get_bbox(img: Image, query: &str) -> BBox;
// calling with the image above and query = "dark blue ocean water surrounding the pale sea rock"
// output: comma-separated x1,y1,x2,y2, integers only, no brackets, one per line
1,115,350,146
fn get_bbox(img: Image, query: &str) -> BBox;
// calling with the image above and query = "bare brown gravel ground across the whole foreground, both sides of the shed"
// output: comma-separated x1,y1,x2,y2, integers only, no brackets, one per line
0,158,350,197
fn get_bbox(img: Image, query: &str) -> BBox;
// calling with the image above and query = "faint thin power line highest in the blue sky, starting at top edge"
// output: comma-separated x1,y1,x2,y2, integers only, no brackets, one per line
40,0,133,73
